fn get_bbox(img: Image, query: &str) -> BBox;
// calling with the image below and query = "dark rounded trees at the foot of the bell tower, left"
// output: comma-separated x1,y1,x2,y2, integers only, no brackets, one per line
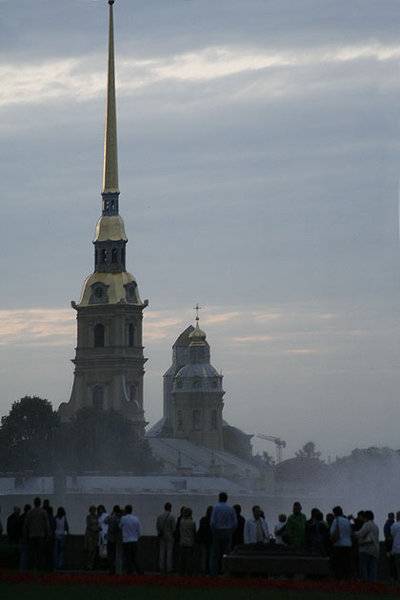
0,396,160,475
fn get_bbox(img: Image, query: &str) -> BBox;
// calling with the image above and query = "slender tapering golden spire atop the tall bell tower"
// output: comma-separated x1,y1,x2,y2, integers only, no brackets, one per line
103,0,119,194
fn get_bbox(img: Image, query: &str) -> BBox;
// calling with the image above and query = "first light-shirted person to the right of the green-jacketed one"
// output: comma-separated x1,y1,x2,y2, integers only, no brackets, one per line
330,506,352,579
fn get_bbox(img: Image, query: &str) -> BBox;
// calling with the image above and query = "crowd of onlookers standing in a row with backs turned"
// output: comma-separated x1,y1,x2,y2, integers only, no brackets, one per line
0,492,400,582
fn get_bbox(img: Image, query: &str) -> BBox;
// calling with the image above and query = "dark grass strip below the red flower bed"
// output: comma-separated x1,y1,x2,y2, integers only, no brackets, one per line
0,583,399,600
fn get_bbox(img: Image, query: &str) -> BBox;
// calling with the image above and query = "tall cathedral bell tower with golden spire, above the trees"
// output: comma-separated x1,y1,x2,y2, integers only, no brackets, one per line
59,0,148,438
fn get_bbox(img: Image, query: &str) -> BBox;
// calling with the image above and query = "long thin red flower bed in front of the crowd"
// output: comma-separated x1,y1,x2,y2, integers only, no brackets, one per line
0,571,400,597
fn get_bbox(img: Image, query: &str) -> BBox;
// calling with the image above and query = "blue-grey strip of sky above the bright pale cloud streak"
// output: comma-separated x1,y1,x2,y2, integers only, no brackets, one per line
0,0,398,56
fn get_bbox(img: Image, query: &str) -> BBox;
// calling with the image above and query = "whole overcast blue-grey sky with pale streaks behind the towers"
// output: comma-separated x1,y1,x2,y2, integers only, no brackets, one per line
0,0,400,457
